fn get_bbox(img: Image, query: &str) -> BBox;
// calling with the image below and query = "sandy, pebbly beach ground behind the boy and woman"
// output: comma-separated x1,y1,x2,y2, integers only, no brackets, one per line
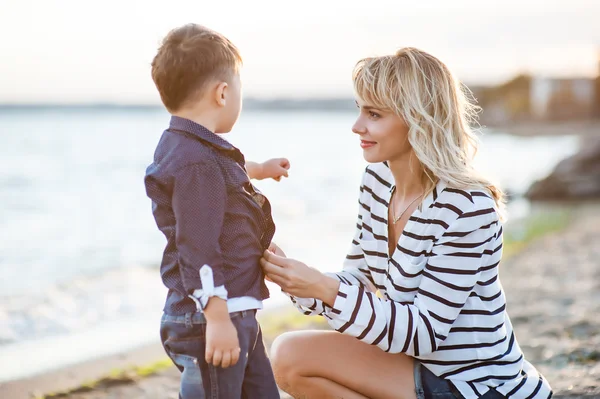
0,204,600,399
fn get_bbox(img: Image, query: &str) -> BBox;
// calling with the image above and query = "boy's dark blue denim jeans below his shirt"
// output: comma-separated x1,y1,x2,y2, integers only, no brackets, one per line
160,310,280,399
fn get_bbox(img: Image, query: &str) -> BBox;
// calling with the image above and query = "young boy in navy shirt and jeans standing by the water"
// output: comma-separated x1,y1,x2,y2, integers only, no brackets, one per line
145,24,289,399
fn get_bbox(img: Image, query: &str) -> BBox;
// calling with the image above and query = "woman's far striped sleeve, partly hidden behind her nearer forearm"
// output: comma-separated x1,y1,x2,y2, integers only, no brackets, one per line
287,172,375,316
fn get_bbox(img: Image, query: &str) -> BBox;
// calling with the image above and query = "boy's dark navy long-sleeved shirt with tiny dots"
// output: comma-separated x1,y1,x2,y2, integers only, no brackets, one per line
144,116,275,315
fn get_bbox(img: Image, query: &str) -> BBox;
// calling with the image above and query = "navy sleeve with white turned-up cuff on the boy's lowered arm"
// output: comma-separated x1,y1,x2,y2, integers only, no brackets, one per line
172,162,227,309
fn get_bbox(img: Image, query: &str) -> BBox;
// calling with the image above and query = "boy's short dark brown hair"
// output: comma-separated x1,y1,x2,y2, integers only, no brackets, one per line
152,24,242,112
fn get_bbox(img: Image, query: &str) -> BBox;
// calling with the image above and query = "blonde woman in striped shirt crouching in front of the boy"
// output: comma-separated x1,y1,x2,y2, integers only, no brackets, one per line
261,48,551,399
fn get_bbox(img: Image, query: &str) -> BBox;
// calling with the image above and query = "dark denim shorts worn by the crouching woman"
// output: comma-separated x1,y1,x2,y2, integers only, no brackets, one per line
415,360,506,399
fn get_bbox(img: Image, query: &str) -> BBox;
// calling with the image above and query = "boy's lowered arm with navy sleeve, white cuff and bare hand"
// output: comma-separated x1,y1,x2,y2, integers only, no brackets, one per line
172,162,240,367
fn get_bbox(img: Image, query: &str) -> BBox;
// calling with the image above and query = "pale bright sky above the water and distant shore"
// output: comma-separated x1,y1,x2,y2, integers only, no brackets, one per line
0,0,600,104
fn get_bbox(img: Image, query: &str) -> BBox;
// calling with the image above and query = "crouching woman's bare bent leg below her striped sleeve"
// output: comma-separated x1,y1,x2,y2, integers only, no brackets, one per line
271,331,416,399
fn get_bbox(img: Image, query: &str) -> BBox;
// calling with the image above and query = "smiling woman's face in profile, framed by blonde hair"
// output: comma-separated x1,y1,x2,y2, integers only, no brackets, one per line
352,98,411,163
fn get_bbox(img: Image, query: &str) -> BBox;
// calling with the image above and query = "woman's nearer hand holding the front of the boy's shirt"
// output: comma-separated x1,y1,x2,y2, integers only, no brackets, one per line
260,247,339,305
